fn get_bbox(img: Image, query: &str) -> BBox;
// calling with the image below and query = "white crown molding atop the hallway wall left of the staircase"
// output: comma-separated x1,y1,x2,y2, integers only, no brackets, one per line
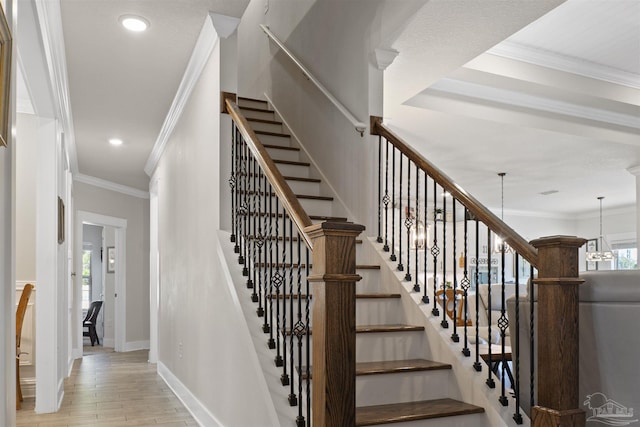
144,13,240,176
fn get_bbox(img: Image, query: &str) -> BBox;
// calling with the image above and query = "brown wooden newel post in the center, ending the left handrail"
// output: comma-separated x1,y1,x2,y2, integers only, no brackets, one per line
305,222,364,427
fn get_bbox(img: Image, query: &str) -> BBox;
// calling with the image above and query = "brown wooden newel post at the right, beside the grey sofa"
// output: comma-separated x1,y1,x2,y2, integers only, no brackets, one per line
531,236,586,427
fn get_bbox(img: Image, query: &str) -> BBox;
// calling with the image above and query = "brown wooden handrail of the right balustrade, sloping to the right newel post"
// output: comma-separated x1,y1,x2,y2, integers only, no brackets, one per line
370,116,538,268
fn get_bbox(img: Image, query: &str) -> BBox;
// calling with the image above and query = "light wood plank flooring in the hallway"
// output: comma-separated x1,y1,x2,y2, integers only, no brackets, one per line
16,348,198,427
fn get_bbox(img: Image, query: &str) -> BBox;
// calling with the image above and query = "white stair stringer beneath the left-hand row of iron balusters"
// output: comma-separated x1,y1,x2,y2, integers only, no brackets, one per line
218,230,298,426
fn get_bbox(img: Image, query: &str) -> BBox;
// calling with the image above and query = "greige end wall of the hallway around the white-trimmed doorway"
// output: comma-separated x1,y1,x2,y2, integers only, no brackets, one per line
74,182,149,348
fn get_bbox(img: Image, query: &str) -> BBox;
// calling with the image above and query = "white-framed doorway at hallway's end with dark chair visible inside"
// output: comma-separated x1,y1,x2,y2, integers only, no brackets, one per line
73,211,127,358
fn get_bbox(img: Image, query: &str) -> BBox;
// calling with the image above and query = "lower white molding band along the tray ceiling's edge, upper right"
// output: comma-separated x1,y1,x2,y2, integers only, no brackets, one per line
427,78,640,129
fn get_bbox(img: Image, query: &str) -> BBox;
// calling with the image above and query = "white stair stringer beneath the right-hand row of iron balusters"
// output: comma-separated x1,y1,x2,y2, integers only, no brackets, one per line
363,237,531,427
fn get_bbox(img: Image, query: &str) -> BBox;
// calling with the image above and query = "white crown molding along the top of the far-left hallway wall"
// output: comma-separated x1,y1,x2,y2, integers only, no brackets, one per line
34,0,78,174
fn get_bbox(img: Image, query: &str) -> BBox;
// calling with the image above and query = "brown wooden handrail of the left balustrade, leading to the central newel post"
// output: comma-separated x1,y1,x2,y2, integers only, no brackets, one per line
225,98,313,250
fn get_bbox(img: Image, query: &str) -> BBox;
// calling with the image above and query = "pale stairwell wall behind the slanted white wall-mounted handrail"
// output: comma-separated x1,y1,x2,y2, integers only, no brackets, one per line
238,0,417,230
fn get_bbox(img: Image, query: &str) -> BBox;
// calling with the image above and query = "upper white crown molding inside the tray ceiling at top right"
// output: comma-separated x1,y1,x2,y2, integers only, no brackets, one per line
487,41,640,89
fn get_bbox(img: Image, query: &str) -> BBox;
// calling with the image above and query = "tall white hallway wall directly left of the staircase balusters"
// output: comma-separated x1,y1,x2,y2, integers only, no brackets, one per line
153,23,273,427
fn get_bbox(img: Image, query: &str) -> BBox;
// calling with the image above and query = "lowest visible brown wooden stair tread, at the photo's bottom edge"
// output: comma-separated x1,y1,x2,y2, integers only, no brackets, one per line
356,398,484,426
